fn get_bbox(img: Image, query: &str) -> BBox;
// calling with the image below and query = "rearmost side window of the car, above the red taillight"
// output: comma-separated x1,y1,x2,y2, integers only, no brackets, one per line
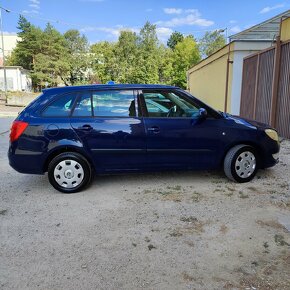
42,93,76,117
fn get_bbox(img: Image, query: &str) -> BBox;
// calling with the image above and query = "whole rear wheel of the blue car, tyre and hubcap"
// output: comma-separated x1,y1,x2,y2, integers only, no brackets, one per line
48,152,92,193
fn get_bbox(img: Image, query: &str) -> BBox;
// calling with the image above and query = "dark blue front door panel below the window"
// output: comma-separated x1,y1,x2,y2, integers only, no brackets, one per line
144,118,224,169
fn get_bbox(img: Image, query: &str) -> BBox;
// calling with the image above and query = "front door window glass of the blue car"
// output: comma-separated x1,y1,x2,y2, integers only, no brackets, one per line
143,91,199,118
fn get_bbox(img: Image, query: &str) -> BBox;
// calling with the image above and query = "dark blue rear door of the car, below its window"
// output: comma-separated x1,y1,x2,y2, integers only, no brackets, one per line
71,117,146,172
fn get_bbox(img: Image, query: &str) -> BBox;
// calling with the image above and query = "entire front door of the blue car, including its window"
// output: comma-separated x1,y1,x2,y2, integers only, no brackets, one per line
139,90,222,169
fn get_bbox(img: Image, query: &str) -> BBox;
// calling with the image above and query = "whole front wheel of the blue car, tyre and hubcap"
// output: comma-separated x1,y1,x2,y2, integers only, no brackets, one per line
224,144,258,183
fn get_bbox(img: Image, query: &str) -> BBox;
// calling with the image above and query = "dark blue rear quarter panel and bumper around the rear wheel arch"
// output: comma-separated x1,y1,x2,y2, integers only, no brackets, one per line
8,117,87,174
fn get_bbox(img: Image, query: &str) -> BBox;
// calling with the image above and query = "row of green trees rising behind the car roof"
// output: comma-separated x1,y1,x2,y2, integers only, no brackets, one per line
8,16,215,89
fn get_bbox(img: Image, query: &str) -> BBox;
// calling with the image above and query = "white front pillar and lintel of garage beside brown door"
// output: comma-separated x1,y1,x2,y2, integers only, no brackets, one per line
231,41,272,115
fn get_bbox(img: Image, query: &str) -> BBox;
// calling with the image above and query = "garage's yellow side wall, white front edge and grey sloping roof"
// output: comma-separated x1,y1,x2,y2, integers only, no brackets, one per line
188,10,290,115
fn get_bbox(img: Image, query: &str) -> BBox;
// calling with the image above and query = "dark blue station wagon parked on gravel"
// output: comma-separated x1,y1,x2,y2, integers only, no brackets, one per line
8,85,279,193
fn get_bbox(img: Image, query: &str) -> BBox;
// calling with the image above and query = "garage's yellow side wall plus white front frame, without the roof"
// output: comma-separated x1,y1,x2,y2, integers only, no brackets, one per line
188,41,272,115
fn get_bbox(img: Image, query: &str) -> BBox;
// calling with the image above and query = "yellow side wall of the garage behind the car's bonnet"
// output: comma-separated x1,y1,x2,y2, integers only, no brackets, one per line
188,43,234,111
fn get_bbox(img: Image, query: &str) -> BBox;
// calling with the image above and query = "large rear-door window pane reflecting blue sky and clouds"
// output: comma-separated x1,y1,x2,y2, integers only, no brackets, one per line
92,90,136,117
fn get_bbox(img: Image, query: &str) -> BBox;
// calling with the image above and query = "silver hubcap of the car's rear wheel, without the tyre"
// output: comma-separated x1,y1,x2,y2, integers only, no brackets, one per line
54,159,84,188
